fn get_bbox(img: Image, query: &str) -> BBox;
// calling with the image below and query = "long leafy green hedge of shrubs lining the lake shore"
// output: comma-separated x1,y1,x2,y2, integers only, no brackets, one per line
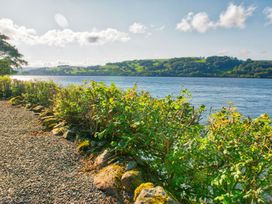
0,76,272,203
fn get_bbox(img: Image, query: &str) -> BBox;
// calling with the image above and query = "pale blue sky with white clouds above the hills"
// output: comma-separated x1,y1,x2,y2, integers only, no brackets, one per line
0,0,272,67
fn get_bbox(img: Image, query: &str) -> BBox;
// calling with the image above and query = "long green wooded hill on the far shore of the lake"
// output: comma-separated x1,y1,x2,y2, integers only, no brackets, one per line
22,56,272,78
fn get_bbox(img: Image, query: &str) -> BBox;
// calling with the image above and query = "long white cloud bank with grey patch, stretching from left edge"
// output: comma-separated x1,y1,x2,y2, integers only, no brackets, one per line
0,19,130,47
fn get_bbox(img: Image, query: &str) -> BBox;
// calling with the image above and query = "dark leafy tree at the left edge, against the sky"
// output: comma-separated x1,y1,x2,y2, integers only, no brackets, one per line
0,33,27,75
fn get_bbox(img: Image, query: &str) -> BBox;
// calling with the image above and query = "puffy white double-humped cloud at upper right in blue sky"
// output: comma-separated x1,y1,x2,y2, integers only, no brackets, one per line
176,4,255,33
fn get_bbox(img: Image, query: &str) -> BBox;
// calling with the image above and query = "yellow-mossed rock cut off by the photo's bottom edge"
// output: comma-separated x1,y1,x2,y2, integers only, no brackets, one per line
134,183,178,204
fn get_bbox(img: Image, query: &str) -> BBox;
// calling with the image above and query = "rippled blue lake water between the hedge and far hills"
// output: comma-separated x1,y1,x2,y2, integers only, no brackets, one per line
13,76,272,117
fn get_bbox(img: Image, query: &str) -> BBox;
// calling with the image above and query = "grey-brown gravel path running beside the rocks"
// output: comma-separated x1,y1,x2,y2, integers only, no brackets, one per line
0,101,114,204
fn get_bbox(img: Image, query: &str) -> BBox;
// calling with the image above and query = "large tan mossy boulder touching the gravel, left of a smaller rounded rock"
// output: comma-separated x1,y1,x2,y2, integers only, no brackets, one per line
94,164,124,196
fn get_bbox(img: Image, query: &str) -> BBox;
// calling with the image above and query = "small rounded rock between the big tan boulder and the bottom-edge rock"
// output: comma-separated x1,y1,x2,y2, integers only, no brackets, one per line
121,170,143,194
